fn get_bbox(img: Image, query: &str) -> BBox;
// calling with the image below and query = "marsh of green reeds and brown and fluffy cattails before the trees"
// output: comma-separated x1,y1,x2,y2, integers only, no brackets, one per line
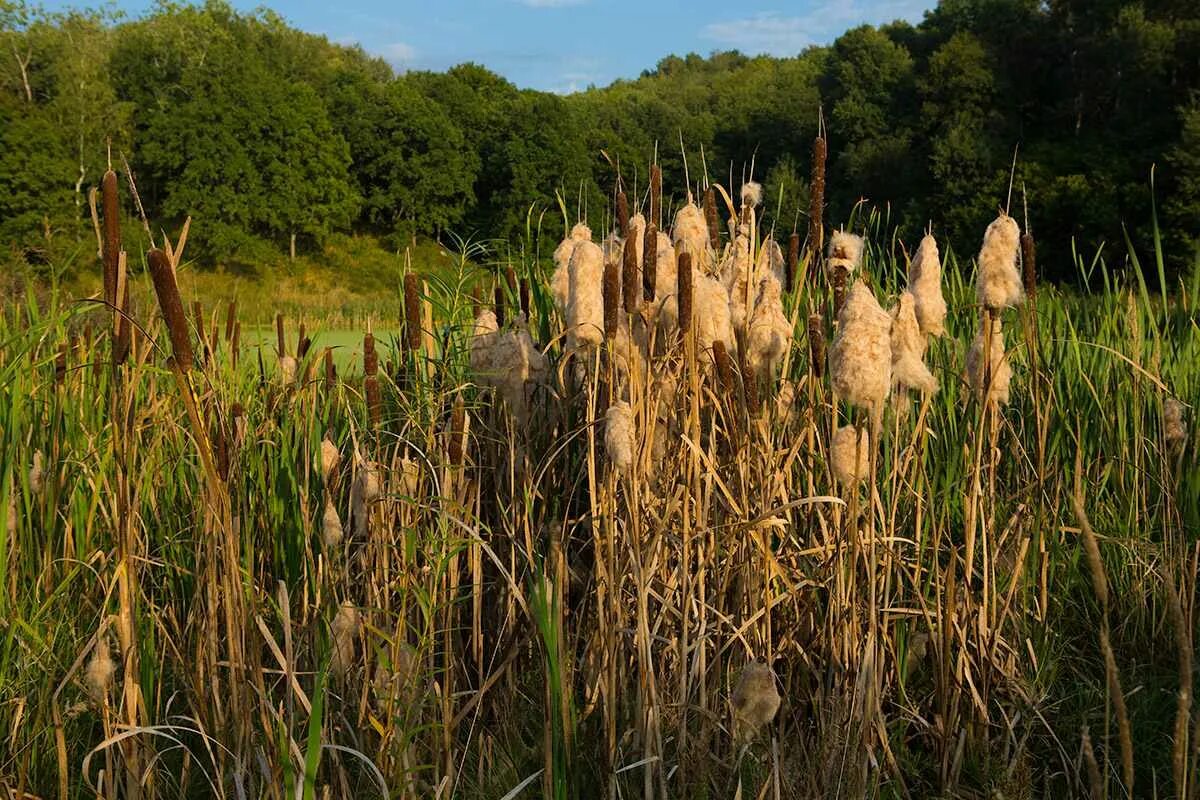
0,158,1200,799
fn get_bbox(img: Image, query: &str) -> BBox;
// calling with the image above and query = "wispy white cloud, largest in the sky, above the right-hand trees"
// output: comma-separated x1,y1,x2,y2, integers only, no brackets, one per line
700,0,930,55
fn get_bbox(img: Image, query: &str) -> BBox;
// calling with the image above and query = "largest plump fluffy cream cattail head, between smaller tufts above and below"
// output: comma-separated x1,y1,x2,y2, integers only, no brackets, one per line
829,281,892,415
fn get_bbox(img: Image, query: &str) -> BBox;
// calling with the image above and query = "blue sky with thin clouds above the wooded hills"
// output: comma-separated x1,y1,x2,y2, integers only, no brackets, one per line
44,0,936,92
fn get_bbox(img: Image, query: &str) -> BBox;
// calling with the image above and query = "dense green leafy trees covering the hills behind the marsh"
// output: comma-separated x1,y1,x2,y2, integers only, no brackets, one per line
0,0,1200,277
